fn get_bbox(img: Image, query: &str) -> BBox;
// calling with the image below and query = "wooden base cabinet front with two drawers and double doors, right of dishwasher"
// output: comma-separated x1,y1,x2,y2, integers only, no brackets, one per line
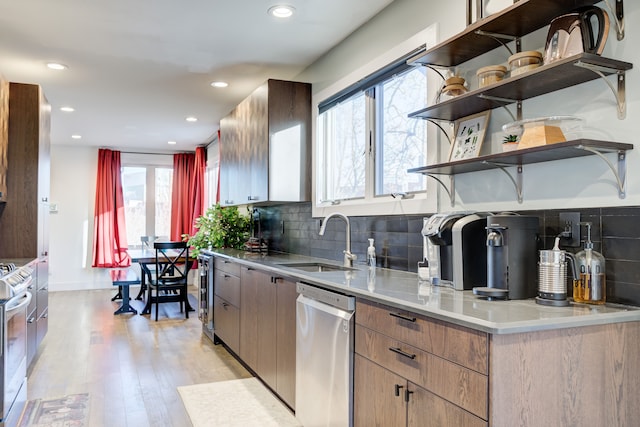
354,300,489,427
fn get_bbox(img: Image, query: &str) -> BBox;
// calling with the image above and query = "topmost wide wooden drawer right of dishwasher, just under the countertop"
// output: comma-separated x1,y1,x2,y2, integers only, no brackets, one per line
356,300,489,374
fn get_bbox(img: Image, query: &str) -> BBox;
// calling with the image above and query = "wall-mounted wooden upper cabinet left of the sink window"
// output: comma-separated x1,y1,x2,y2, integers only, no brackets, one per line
220,79,311,206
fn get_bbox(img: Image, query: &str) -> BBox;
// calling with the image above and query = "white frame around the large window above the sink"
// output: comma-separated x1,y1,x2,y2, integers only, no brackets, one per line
312,24,442,217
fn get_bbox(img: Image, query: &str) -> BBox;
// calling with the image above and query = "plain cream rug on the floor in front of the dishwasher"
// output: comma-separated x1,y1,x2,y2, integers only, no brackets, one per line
178,378,301,427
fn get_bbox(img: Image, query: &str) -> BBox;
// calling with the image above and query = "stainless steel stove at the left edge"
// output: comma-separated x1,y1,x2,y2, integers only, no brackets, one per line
0,264,33,427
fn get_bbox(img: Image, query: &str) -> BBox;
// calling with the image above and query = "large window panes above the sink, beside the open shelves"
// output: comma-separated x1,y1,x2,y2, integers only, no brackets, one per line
316,52,427,204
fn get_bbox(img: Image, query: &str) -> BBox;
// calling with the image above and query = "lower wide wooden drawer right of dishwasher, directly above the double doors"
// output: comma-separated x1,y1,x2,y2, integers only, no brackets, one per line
355,326,489,419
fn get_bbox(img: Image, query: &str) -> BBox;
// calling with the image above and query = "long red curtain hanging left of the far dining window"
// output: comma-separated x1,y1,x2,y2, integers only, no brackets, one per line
92,149,131,267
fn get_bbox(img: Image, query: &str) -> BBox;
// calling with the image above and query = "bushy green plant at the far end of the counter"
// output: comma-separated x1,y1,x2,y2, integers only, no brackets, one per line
182,204,250,256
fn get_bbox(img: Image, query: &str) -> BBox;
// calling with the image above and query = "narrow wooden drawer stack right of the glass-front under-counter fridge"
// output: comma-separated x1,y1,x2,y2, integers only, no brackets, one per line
213,258,241,354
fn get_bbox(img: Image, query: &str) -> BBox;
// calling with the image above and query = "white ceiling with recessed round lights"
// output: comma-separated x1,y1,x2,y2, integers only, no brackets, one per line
0,0,393,152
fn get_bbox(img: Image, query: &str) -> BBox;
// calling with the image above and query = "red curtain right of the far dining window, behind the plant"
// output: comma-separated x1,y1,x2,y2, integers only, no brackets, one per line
170,147,206,241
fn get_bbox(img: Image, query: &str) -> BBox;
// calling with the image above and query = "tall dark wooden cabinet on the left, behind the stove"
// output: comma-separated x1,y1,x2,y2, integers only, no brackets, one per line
0,83,51,364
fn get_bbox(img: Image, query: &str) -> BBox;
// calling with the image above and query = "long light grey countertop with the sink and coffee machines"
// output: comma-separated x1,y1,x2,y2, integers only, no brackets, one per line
208,249,640,334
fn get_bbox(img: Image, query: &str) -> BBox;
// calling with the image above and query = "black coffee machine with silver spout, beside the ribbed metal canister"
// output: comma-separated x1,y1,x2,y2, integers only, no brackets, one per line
473,214,538,299
